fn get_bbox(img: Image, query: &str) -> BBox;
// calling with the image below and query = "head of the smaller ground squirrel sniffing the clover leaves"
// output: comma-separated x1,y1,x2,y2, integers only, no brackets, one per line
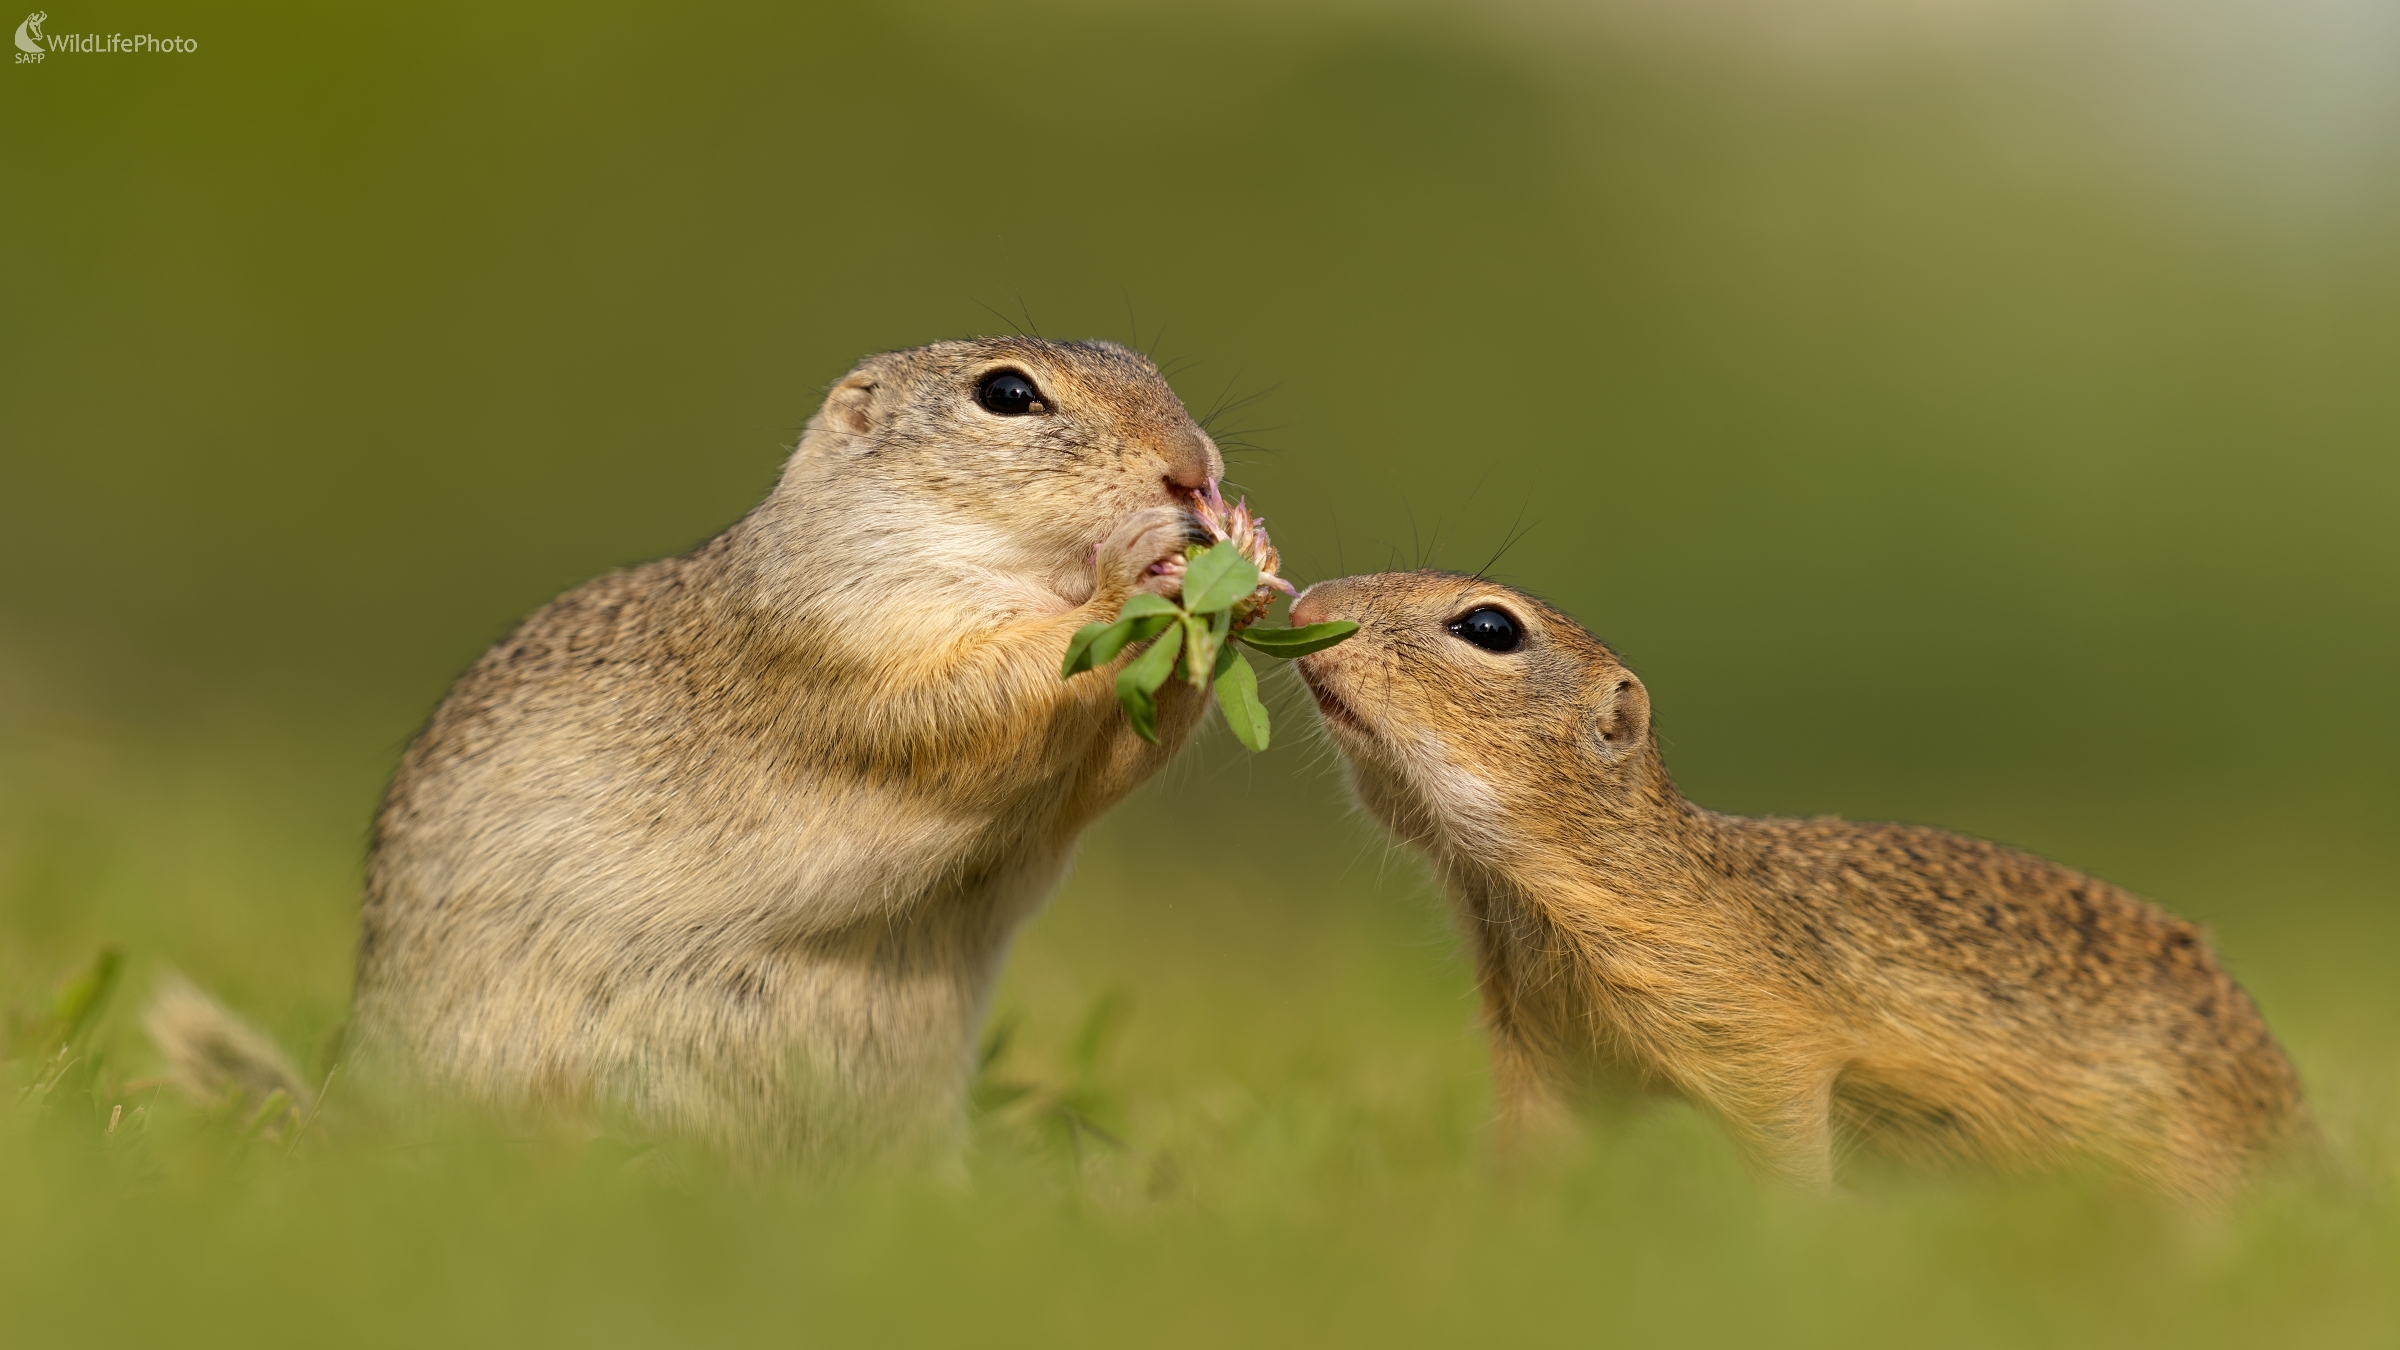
1291,572,1666,850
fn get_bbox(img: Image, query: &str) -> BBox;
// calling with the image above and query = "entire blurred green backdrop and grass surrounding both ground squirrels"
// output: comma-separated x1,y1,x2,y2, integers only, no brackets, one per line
0,0,2400,1345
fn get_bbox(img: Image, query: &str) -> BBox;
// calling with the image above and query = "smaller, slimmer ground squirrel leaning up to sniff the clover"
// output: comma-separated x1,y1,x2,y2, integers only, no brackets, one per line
1291,572,2311,1199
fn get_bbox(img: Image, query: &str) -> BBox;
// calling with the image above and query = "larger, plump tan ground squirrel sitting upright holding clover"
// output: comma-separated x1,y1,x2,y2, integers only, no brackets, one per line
353,339,1224,1158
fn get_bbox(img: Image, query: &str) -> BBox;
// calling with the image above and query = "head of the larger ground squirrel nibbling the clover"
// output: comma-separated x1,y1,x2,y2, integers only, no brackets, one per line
785,336,1224,603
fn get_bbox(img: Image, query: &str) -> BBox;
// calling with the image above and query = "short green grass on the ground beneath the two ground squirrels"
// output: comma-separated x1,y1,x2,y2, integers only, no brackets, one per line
0,711,2400,1345
